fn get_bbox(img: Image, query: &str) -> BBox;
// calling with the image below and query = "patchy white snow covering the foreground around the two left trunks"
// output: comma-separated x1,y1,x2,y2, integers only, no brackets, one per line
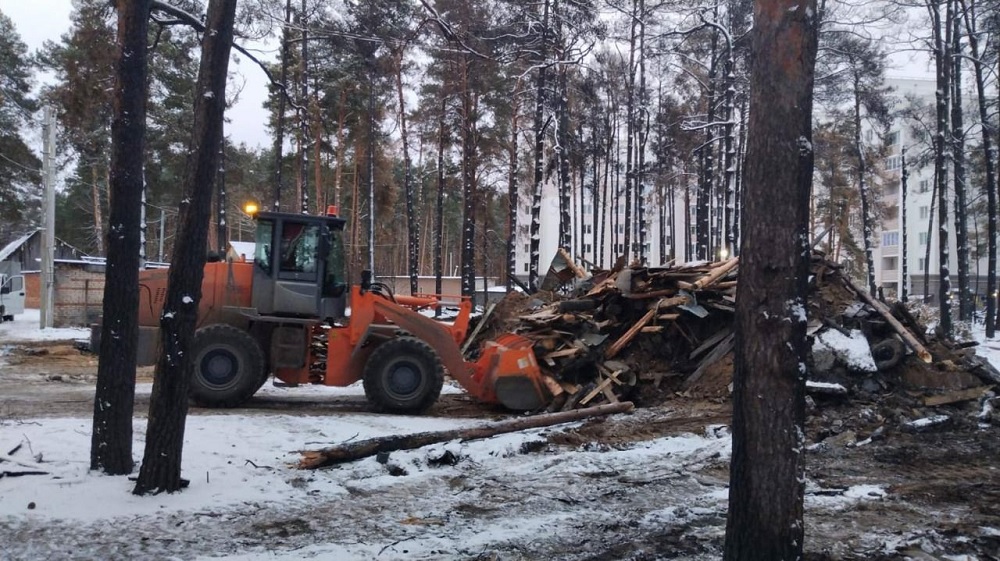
0,311,1000,561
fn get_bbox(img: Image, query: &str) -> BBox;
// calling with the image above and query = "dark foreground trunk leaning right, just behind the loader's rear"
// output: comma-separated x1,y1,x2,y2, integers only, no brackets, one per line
133,0,236,495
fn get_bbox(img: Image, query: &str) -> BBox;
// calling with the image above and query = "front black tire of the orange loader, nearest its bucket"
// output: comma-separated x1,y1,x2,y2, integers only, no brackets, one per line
363,337,444,413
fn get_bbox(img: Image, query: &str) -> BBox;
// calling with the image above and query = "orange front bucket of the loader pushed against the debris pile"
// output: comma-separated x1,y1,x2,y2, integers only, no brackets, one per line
483,333,550,411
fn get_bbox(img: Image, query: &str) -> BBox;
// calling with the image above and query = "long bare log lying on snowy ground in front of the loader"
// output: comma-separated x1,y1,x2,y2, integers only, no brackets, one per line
298,401,634,469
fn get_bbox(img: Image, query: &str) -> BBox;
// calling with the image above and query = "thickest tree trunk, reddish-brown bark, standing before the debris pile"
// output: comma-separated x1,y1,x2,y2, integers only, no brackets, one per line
724,0,817,561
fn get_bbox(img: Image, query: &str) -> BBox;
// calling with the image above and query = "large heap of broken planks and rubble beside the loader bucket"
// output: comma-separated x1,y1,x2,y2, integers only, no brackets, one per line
467,249,1000,416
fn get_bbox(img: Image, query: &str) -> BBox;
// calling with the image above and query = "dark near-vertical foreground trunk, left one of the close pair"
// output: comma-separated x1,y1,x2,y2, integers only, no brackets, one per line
90,0,152,475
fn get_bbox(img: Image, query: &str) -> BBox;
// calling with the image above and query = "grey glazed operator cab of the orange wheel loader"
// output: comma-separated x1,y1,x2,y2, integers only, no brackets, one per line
251,208,348,320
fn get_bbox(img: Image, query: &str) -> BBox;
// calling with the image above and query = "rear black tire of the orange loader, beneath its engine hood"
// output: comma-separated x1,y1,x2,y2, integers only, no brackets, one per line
188,324,266,407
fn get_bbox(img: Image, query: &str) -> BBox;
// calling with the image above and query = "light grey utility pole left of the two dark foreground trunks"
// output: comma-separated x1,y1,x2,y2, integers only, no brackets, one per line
39,105,56,329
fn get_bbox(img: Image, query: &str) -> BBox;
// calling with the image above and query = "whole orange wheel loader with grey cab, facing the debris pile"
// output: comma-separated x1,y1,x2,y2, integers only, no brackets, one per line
111,209,550,413
